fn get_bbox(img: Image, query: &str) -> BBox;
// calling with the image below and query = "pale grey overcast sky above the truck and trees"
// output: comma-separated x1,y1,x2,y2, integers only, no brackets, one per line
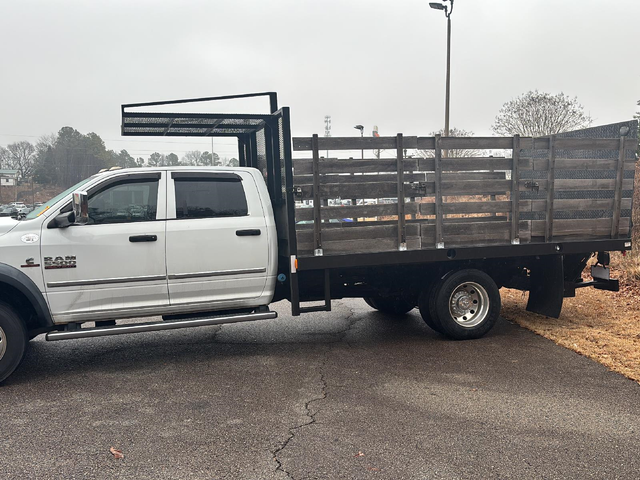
0,0,640,158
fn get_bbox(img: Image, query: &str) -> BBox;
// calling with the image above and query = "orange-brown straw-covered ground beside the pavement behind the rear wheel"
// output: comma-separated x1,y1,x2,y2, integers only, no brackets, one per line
502,258,640,383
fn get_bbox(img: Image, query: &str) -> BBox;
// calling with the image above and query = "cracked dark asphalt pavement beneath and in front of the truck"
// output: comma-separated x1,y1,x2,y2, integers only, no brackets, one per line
0,300,640,479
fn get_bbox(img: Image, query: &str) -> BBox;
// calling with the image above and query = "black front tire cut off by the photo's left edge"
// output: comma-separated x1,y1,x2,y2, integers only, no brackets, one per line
0,303,29,382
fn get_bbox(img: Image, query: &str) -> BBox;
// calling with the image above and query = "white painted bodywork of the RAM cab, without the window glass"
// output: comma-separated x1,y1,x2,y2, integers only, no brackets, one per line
0,167,277,324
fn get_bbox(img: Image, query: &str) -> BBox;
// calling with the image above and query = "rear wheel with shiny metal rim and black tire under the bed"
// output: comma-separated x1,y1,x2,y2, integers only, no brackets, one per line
429,269,501,340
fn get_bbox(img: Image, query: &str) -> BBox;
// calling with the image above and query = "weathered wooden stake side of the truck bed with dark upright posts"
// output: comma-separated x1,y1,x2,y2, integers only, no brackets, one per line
293,132,637,258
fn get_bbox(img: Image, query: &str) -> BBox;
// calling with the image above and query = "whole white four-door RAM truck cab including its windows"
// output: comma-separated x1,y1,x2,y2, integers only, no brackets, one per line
0,167,277,377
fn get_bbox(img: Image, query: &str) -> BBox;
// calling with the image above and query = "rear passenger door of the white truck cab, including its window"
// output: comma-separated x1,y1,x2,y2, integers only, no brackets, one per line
167,170,272,309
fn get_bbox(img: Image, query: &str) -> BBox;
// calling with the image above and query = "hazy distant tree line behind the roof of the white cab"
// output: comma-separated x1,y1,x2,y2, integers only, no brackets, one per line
0,127,238,188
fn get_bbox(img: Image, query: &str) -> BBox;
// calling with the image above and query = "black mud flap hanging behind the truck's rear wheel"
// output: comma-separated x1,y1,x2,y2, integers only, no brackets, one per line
527,255,564,318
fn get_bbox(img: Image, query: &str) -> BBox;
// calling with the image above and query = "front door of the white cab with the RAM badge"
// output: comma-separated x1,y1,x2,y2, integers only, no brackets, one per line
41,172,169,322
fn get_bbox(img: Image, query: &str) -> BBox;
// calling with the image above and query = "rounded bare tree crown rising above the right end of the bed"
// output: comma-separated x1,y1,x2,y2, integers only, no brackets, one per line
491,90,592,137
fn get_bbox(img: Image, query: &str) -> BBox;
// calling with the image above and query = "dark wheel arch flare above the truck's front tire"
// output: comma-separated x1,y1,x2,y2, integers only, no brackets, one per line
0,263,54,334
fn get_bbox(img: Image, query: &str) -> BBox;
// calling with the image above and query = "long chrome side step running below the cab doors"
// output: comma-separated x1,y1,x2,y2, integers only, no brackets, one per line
45,311,278,342
